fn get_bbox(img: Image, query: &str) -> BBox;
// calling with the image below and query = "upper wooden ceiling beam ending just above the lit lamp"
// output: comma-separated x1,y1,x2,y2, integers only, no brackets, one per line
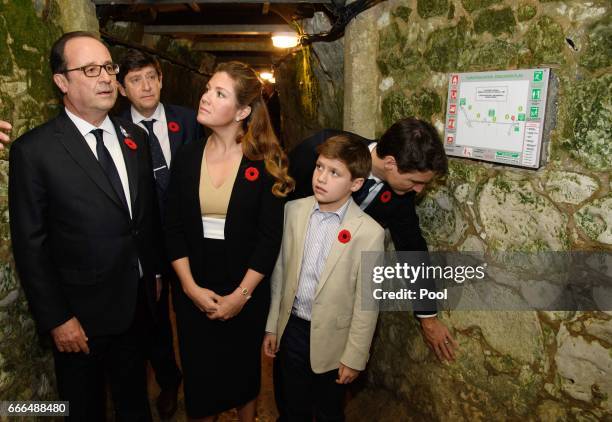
144,25,295,35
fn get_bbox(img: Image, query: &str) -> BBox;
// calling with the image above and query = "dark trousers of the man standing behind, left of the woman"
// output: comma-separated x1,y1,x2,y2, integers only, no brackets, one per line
148,276,183,390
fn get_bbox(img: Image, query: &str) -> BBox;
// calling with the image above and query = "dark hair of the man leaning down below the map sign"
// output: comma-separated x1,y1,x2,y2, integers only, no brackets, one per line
376,117,448,175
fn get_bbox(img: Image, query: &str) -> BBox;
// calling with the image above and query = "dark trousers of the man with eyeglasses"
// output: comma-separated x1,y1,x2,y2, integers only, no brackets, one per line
53,282,151,422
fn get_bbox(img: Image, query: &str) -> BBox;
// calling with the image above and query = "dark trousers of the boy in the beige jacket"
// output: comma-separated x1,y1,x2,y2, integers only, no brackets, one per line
278,315,345,422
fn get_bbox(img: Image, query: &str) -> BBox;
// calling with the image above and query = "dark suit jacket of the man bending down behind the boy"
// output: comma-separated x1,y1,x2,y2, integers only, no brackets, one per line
289,129,427,251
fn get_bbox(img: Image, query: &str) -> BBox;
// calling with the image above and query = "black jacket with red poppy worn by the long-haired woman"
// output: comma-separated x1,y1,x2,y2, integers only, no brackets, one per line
164,141,285,294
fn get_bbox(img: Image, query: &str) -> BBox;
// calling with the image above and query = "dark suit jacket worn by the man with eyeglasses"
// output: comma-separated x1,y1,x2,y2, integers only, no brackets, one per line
9,111,159,336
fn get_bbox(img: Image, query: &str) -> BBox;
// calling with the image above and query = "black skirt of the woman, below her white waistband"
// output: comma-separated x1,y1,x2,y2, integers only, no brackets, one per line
175,239,270,417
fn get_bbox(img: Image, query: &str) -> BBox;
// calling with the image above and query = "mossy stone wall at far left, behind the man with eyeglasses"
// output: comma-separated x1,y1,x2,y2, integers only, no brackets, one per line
0,0,98,400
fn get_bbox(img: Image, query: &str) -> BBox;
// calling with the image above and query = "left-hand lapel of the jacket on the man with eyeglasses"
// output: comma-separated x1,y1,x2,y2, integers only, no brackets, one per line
56,111,127,212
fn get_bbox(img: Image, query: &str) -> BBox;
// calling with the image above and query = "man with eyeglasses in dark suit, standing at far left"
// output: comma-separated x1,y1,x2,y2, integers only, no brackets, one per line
9,32,161,422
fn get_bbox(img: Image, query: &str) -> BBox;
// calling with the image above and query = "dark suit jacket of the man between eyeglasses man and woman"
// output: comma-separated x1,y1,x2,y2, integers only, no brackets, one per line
121,104,204,212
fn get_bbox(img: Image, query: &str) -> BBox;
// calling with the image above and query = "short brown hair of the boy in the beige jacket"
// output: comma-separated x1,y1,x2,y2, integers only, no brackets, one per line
317,133,372,180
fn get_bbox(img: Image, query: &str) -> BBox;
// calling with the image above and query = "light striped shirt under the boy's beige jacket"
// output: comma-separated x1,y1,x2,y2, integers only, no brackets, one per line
291,198,352,321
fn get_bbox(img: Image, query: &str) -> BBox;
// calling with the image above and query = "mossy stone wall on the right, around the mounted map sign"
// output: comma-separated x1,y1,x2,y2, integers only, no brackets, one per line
345,0,612,421
